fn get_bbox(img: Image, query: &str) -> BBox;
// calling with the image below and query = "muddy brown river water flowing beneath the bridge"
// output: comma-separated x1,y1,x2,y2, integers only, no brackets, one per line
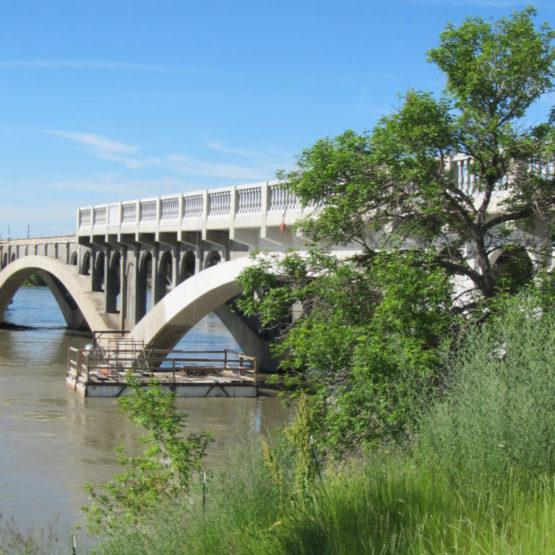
0,287,287,530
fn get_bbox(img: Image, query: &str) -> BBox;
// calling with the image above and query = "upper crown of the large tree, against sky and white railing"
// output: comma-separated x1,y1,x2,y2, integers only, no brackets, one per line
282,8,555,298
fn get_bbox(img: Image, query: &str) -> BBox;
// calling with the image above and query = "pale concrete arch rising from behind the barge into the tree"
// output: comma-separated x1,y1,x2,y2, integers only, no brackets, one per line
128,257,252,349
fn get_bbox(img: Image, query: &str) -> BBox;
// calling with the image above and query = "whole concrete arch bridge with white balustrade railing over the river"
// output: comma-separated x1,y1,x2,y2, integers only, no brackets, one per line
0,165,554,369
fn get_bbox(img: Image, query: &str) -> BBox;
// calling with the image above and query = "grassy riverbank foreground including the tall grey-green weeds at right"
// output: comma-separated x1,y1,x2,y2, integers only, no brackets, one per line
98,295,555,555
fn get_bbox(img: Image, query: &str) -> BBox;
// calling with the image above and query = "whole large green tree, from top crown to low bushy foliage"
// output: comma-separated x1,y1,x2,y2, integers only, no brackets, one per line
240,8,555,451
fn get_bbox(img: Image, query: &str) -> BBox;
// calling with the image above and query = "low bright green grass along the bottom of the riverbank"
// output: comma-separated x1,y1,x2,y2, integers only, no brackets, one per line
98,438,555,555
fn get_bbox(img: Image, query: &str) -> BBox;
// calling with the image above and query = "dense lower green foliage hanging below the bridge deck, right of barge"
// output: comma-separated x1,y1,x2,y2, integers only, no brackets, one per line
239,252,456,452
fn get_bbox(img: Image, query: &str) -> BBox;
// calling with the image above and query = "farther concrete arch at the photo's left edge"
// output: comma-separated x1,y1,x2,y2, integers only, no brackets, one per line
0,256,109,331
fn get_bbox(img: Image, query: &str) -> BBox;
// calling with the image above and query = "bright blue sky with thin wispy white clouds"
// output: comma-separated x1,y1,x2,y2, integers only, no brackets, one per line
0,0,555,237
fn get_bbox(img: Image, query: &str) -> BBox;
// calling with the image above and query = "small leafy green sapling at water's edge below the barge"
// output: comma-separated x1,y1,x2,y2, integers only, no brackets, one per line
84,374,210,533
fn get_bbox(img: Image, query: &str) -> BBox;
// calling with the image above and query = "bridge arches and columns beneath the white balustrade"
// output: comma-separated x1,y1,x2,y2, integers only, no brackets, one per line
0,213,554,370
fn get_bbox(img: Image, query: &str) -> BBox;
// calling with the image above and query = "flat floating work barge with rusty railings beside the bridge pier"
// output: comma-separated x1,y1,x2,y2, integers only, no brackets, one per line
66,341,259,397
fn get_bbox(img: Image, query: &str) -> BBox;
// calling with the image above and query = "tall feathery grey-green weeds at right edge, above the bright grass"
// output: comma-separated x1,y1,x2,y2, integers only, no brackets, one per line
419,290,555,485
